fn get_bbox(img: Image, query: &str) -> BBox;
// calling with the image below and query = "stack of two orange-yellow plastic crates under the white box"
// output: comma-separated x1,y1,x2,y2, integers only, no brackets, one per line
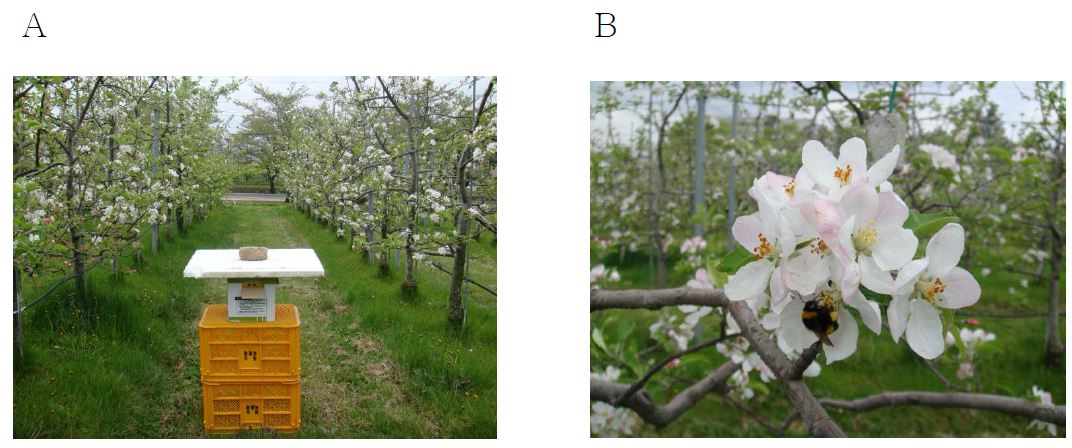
198,304,301,432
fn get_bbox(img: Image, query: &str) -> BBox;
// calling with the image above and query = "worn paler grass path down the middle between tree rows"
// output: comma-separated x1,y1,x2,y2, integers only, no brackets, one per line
161,205,438,437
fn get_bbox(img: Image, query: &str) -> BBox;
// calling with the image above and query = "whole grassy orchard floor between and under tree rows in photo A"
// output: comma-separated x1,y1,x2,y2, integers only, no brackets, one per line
13,204,496,438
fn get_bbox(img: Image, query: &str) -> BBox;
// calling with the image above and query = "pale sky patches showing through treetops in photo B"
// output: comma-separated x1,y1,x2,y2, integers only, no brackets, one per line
590,81,1059,144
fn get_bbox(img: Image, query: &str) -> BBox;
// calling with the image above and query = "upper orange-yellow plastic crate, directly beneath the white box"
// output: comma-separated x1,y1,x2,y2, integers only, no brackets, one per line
198,304,301,378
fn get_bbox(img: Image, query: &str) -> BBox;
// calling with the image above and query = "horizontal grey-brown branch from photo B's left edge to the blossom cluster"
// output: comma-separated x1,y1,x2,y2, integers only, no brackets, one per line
591,286,729,311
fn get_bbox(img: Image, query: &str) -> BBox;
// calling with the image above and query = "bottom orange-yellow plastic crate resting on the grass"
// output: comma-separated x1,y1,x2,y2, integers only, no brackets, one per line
202,378,301,433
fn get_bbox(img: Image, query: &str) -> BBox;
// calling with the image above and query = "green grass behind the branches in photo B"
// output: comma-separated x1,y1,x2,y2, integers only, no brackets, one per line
591,243,1066,437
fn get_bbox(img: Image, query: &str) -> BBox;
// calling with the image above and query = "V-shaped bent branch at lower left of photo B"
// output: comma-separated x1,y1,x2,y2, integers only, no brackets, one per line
590,361,738,428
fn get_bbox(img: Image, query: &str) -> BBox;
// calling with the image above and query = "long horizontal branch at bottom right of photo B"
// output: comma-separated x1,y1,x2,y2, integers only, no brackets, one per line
819,391,1064,427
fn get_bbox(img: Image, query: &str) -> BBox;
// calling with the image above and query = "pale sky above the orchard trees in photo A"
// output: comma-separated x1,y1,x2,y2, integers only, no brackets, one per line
206,76,490,132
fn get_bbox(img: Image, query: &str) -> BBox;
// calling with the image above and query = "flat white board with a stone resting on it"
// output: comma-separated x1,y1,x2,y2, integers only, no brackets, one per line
182,249,324,279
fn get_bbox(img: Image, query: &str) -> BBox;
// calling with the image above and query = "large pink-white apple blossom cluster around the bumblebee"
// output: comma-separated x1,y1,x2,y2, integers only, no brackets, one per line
725,138,980,363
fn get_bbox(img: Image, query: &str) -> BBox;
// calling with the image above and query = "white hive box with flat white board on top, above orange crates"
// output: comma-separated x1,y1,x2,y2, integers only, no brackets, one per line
182,249,324,322
